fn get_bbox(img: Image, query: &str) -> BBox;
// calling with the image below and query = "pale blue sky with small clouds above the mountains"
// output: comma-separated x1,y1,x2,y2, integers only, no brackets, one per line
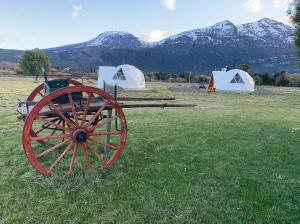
0,0,291,49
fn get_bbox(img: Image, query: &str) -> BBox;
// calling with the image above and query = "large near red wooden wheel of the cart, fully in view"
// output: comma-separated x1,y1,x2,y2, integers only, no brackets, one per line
22,86,127,176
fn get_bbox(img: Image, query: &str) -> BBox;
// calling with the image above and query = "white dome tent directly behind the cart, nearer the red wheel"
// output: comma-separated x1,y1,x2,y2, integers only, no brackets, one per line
97,65,145,90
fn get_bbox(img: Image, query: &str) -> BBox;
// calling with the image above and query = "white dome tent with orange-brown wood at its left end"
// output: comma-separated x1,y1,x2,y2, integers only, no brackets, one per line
208,69,255,92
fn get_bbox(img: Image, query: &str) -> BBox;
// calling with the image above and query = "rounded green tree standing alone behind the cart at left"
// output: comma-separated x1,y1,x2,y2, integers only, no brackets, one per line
20,49,51,81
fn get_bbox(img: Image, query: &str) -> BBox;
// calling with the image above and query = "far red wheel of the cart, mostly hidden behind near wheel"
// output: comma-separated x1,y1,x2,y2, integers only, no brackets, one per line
26,79,82,144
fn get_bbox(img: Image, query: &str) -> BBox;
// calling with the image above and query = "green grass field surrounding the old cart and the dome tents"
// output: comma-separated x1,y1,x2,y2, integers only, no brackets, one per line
0,81,300,224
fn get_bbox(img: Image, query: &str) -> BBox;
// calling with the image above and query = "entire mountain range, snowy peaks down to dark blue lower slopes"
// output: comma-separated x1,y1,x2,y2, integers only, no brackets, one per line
0,18,300,74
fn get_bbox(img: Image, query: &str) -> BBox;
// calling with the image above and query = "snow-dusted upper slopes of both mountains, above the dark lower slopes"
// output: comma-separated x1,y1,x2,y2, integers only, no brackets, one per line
47,18,293,50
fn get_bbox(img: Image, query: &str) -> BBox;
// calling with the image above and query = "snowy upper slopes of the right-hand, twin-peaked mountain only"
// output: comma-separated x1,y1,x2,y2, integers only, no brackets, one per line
153,18,294,45
